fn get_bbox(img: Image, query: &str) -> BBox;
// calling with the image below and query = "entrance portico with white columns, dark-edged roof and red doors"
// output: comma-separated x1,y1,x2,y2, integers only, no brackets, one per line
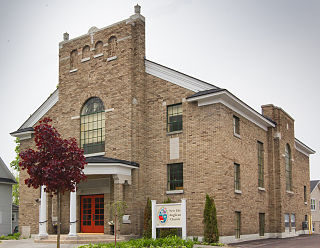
39,156,139,239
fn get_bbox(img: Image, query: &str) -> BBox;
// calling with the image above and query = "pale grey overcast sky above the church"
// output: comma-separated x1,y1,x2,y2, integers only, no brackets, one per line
0,0,320,179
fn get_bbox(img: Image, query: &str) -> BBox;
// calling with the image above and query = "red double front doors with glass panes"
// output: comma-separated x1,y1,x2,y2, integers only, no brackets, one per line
81,195,104,233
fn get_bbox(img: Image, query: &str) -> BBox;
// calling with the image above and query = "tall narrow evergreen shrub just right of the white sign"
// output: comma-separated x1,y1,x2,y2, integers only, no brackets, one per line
203,194,219,243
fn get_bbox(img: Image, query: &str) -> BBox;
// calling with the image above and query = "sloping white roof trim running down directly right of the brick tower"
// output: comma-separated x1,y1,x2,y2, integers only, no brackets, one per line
145,60,217,92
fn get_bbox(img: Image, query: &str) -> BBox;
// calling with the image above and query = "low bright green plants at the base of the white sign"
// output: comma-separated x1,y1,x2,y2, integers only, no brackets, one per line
78,236,224,248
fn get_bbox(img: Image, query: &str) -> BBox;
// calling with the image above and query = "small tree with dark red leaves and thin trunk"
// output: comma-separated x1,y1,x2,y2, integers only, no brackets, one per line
19,118,86,248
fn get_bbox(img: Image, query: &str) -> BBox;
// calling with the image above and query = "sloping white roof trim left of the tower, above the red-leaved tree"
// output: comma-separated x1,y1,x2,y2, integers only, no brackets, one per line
18,89,59,130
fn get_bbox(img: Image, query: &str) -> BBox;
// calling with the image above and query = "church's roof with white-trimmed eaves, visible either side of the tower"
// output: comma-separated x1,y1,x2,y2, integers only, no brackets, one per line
10,59,315,156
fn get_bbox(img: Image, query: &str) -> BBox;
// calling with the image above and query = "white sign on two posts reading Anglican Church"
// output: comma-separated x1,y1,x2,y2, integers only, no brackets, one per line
151,199,187,239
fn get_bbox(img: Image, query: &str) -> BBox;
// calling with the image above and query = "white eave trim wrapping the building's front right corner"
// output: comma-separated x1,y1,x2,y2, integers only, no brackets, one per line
187,91,275,131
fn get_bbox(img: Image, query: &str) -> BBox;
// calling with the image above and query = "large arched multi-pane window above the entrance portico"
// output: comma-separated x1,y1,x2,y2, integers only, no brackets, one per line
80,97,105,154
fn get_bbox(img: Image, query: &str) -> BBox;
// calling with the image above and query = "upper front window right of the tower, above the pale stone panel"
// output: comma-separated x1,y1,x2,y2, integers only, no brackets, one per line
167,103,182,133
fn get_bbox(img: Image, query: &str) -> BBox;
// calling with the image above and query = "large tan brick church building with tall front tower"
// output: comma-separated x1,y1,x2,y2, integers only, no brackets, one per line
11,6,315,242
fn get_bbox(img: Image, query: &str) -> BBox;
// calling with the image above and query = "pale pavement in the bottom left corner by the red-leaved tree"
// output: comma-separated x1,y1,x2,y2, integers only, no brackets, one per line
0,239,84,248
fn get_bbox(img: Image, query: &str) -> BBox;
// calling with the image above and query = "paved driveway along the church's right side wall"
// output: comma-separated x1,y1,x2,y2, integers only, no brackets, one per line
229,234,320,248
